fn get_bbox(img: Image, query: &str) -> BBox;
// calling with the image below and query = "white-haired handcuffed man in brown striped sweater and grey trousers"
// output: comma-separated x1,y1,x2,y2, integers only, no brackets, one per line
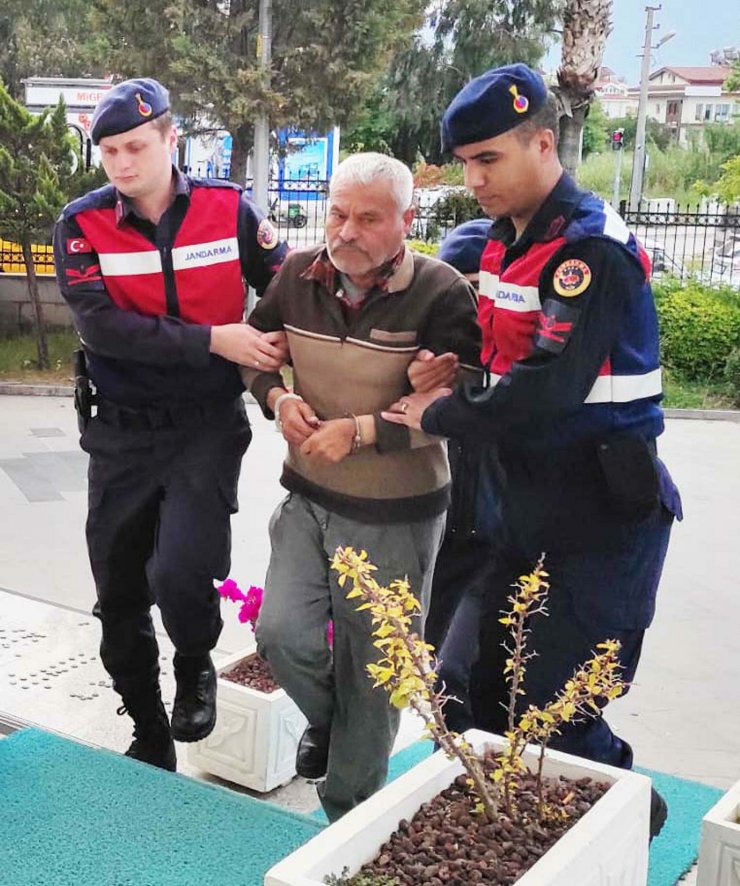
244,153,480,820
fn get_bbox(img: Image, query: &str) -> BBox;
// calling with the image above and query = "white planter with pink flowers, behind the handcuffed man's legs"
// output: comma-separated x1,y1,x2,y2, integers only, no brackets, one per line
188,649,307,791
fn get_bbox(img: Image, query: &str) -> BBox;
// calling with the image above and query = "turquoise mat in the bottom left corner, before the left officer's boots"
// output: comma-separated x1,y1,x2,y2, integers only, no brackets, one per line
0,729,321,886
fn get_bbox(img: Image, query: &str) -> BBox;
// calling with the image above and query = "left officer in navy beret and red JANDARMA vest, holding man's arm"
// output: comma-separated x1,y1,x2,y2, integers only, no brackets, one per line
54,79,286,770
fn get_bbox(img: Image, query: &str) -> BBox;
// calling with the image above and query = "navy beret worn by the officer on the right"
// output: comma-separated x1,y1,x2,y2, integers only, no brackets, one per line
440,64,547,151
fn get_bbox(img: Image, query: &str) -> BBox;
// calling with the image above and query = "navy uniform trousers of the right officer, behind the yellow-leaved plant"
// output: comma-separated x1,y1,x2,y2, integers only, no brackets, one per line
468,504,680,768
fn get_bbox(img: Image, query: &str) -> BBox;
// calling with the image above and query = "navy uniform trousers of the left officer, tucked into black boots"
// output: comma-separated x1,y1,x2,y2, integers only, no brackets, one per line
80,398,252,699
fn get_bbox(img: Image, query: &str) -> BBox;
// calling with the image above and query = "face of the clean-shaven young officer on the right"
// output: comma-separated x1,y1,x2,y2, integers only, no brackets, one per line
454,130,552,224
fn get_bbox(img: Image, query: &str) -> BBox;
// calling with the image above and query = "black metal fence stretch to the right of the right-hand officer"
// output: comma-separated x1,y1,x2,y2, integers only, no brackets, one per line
620,201,740,288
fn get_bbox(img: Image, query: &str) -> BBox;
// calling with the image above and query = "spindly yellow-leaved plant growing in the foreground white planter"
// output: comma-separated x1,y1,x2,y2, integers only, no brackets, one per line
331,547,625,821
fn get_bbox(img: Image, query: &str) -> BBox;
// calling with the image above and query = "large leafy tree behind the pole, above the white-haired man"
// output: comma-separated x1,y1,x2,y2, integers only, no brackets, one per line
95,0,423,182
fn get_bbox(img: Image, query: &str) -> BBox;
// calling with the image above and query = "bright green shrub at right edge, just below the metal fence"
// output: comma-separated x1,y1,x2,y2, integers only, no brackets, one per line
655,281,740,379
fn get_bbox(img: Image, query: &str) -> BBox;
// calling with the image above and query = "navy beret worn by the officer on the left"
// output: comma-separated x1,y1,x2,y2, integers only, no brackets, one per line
90,77,170,145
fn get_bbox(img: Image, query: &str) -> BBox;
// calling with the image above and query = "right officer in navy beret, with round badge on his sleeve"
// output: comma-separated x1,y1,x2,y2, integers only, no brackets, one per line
385,64,681,835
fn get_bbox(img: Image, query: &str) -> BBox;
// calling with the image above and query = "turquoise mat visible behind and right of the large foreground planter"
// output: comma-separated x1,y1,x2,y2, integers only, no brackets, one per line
311,741,723,886
